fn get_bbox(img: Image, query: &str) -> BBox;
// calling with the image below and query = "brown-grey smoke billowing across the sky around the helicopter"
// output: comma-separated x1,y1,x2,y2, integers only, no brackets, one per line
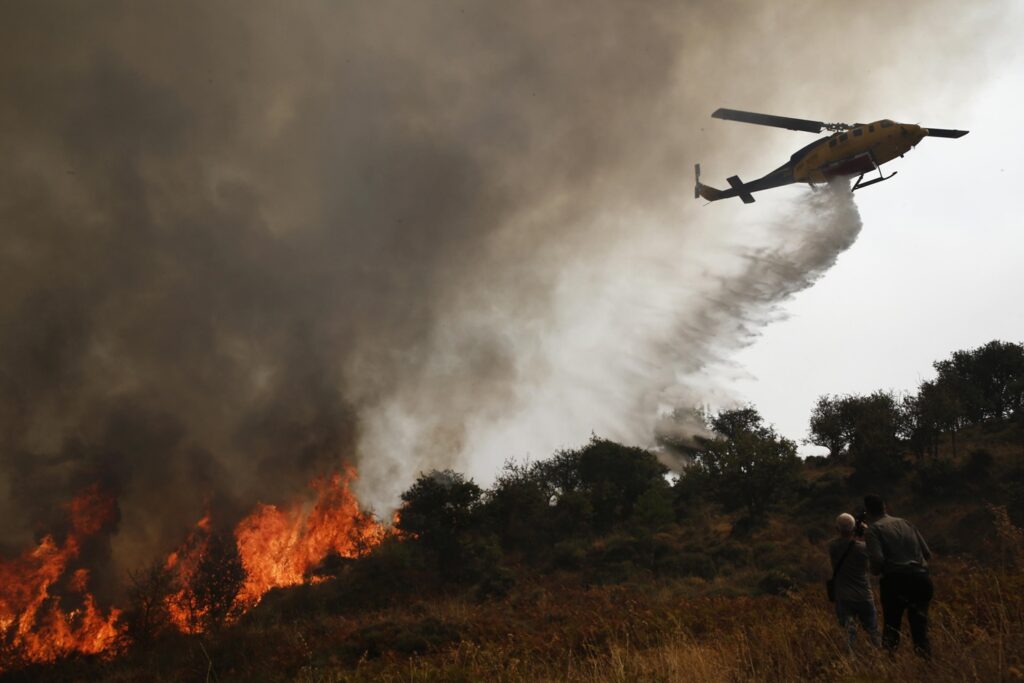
0,0,1019,565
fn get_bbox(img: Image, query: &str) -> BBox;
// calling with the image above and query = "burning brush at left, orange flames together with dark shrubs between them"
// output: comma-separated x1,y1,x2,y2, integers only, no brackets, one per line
0,470,384,671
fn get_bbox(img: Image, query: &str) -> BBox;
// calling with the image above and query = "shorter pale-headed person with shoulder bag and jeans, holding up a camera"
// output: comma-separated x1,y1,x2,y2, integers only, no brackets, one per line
828,512,881,652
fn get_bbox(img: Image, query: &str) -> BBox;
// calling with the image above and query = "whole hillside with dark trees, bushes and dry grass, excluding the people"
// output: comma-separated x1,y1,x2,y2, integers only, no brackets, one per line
5,342,1024,681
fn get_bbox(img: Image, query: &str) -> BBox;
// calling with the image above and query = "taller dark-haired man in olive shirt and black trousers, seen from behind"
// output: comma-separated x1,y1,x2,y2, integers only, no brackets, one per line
864,495,933,657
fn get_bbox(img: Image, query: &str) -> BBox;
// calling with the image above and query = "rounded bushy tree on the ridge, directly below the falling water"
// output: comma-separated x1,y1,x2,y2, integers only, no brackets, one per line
694,408,800,520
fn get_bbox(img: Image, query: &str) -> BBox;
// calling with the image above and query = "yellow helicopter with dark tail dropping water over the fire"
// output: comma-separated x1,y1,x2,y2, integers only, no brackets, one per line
693,109,968,204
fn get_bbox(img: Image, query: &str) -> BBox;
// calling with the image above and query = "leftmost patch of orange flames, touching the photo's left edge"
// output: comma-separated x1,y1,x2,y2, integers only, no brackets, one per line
0,486,121,668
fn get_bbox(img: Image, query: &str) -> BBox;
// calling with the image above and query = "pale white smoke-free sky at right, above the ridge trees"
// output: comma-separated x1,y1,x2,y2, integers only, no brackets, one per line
724,22,1024,452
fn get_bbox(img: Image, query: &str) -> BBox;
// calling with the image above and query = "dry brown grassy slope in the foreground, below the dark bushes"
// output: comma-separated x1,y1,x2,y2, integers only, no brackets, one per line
54,561,1024,683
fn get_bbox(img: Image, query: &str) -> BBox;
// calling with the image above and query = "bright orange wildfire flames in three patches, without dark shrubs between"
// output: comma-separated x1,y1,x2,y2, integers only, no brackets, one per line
0,469,385,670
